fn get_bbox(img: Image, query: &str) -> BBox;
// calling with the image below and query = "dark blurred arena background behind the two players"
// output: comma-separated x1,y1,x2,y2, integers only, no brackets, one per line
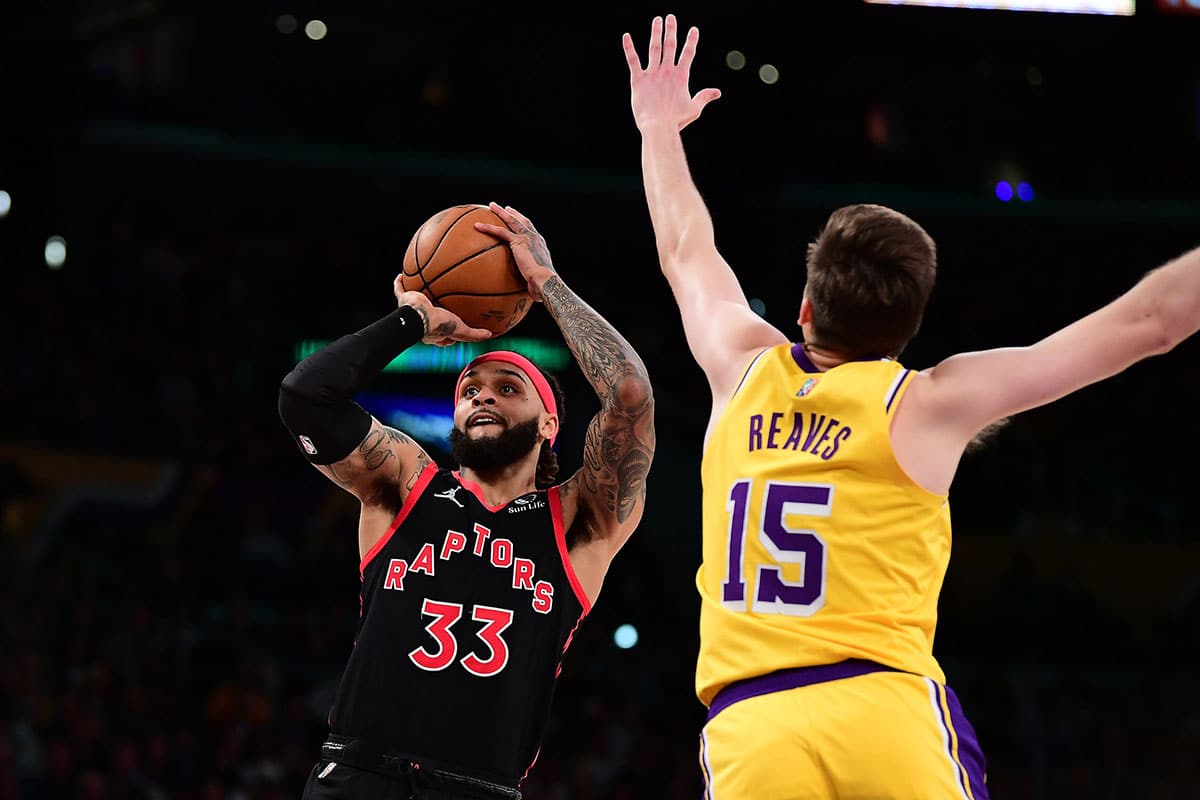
0,0,1200,800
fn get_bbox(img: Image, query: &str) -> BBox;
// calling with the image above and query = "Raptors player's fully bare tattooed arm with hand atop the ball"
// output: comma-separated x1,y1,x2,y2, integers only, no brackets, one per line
476,203,654,568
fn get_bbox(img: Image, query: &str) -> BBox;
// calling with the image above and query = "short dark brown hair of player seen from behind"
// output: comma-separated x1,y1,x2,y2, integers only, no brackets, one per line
805,205,937,357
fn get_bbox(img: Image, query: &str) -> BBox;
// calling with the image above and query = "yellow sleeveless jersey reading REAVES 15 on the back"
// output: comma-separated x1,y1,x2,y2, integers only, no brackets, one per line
696,344,950,705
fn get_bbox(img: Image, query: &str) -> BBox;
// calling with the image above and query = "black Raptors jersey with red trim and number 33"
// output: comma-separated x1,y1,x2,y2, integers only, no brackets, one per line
329,465,587,787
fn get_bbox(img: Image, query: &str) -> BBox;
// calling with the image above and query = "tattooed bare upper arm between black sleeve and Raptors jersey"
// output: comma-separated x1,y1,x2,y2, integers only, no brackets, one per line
317,417,432,509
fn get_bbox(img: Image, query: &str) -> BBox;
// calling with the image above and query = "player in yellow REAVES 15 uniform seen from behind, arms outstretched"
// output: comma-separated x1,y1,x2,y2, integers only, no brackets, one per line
624,17,1200,800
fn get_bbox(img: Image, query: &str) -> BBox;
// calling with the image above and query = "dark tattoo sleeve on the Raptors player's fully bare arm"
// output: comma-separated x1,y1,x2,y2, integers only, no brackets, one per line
542,275,654,523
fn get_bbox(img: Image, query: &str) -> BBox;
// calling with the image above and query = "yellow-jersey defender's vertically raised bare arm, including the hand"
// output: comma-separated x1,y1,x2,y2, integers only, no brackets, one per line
623,14,787,414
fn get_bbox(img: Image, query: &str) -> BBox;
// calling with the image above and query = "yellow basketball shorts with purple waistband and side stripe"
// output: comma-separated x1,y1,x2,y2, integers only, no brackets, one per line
700,661,988,800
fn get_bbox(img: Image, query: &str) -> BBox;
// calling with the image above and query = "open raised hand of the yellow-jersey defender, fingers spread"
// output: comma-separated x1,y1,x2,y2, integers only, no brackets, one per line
622,14,721,133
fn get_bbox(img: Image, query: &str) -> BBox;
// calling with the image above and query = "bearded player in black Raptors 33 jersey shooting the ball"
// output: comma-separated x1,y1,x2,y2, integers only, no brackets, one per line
280,204,654,800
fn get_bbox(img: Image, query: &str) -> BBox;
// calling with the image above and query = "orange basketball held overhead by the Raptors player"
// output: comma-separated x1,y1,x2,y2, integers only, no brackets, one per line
400,205,533,335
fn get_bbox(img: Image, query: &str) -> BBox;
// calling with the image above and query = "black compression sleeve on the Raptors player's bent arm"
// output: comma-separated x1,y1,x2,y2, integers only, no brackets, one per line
280,306,425,464
